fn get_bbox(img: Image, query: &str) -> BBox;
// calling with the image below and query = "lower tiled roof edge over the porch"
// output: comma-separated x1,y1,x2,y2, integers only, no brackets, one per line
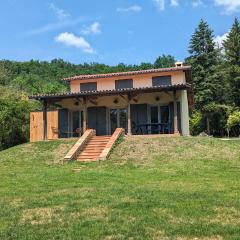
29,83,191,100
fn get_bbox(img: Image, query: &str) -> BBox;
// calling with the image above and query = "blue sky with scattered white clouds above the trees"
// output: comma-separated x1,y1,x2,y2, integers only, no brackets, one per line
0,0,240,65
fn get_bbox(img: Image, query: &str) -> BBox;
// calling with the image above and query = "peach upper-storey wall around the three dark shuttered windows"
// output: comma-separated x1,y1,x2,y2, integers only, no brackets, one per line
70,71,186,92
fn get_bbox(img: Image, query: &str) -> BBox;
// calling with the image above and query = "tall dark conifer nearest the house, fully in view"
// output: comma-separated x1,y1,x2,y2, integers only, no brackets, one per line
187,19,223,109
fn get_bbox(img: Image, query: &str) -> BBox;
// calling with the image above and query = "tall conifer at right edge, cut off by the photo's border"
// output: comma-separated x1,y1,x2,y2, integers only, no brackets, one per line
223,18,240,107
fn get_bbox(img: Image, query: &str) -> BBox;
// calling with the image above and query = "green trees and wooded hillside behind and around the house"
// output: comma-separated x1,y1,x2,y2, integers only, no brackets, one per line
0,18,240,150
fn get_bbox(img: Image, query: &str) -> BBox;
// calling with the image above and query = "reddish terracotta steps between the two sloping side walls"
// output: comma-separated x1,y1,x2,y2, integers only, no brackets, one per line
77,136,111,162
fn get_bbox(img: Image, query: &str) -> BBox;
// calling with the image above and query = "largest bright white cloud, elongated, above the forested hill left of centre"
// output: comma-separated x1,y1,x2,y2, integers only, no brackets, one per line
55,32,94,54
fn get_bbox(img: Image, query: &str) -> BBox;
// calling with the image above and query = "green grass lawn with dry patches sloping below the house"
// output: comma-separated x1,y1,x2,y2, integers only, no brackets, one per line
0,137,240,240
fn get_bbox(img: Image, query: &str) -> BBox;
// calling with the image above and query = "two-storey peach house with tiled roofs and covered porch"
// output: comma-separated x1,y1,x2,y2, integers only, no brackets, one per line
30,62,192,141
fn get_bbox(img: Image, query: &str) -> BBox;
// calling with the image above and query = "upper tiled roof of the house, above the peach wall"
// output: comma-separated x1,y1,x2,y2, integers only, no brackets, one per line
63,66,191,81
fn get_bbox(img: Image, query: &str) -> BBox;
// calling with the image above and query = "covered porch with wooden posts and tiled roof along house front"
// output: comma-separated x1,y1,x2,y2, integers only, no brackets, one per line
32,84,189,139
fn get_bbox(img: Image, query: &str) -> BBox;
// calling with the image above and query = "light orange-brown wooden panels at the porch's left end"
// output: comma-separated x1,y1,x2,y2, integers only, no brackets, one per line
30,111,58,142
